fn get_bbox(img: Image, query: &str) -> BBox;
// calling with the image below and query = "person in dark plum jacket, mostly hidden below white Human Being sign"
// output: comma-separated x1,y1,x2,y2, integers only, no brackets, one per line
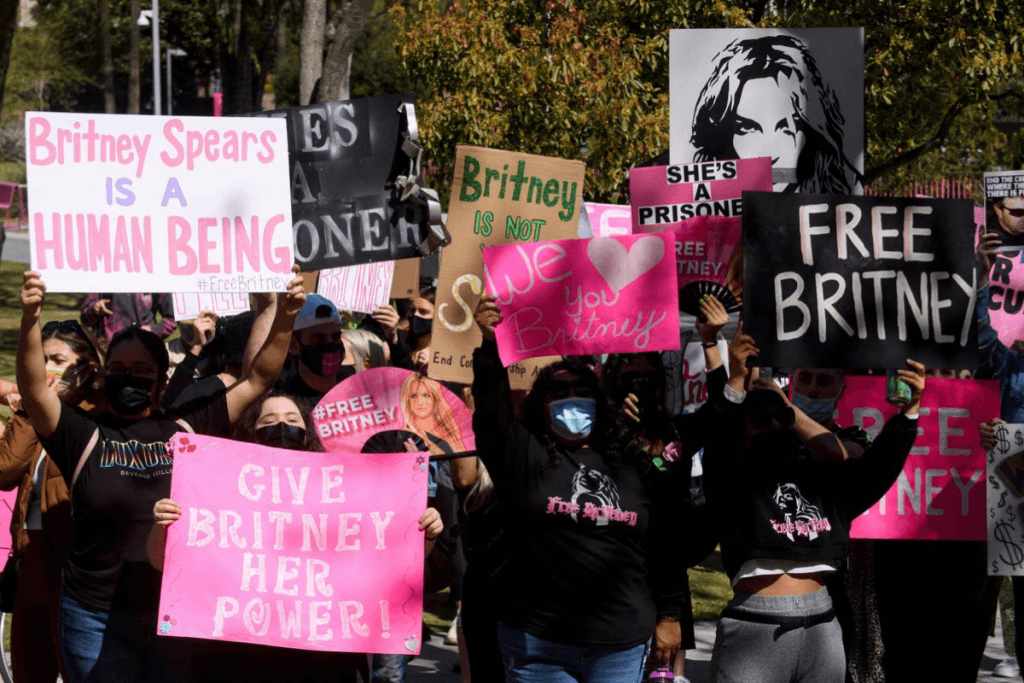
81,293,177,341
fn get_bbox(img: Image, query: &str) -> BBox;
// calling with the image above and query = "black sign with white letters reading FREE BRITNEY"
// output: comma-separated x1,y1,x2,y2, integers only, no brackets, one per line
743,193,978,369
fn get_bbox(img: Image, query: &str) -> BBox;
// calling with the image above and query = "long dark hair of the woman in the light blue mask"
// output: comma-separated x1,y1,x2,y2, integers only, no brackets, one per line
522,357,628,467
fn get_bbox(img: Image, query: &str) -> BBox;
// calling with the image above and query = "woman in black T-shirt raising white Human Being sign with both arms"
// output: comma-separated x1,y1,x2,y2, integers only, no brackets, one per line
17,271,305,683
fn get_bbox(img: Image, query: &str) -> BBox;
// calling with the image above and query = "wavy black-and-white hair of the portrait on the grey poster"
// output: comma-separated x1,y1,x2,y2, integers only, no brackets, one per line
690,35,863,195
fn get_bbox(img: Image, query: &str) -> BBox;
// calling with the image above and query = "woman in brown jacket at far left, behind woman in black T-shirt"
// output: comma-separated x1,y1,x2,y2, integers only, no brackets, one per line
0,321,102,683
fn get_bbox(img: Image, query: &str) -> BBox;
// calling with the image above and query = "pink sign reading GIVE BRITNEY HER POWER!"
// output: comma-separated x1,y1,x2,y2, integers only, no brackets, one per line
158,433,428,654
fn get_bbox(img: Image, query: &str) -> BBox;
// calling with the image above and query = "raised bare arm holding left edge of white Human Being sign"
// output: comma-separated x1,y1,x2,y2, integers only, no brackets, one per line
17,270,60,439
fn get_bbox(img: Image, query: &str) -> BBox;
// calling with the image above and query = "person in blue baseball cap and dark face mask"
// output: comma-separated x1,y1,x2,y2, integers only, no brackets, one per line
275,294,355,403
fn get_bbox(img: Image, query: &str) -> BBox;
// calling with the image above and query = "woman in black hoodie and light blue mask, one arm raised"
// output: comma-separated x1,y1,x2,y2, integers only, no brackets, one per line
473,296,685,683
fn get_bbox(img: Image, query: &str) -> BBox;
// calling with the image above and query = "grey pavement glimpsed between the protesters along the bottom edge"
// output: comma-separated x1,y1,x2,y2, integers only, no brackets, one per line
406,620,1021,683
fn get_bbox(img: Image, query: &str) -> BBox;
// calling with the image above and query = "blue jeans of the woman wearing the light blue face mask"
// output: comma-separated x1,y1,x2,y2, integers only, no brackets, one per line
498,623,650,683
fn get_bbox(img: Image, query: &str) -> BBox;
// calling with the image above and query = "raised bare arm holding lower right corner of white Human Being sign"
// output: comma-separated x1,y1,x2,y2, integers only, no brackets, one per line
226,265,306,423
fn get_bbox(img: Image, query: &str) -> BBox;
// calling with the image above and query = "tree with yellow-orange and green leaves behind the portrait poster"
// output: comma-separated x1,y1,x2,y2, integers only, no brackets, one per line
394,0,1024,200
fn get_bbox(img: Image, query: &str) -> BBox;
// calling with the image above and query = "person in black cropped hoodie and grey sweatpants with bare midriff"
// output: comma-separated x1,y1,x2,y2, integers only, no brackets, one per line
692,309,925,683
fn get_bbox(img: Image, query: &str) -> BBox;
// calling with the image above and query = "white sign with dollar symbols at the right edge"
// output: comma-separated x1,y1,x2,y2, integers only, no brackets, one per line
986,425,1024,577
